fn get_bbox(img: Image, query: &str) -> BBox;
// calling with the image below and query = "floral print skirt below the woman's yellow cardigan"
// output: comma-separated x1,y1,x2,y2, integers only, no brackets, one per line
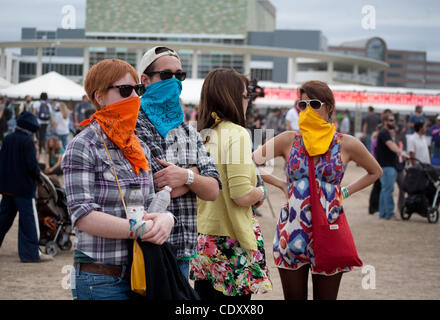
190,216,272,296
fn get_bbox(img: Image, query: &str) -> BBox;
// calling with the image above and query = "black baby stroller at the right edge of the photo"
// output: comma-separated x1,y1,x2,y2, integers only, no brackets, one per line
400,158,440,223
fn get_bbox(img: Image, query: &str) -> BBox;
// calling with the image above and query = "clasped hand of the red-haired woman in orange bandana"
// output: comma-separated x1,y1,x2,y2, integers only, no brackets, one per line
141,213,174,245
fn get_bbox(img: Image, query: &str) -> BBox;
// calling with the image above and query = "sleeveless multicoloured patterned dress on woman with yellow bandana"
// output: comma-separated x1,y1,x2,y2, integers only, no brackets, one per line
273,133,353,275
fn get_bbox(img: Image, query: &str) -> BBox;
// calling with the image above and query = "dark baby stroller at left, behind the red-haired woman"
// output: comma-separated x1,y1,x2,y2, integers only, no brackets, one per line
37,173,73,256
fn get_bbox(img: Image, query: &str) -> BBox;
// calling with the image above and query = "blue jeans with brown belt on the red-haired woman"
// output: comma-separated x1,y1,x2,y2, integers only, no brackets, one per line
70,266,130,300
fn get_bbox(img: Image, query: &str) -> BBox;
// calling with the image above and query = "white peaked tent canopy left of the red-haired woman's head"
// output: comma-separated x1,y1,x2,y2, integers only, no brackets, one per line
0,71,85,101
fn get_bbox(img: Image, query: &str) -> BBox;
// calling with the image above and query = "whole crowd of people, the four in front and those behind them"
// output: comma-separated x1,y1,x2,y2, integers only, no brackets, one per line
0,47,440,301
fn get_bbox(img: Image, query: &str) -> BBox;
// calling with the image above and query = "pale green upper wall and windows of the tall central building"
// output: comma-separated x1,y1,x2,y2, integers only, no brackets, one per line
86,0,276,78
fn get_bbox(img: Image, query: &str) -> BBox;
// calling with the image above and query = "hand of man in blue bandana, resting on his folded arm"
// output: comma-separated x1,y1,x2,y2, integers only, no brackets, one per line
153,158,188,190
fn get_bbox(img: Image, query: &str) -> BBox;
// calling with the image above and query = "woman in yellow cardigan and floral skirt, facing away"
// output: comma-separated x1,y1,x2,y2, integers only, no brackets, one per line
191,68,272,301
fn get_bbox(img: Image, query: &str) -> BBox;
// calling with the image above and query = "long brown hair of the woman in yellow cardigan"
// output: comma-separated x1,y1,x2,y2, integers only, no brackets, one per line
197,68,249,131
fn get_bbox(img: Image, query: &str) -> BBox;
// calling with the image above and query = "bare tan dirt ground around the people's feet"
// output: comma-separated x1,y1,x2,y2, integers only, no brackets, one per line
0,159,440,300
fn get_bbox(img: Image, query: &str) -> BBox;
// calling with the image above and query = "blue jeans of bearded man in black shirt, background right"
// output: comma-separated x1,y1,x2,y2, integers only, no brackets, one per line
379,167,397,220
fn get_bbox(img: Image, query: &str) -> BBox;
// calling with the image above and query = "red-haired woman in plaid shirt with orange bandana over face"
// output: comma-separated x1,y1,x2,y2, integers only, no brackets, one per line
62,59,174,300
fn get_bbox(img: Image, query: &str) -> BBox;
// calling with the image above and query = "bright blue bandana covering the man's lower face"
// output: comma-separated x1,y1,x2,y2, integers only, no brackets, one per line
141,78,183,138
